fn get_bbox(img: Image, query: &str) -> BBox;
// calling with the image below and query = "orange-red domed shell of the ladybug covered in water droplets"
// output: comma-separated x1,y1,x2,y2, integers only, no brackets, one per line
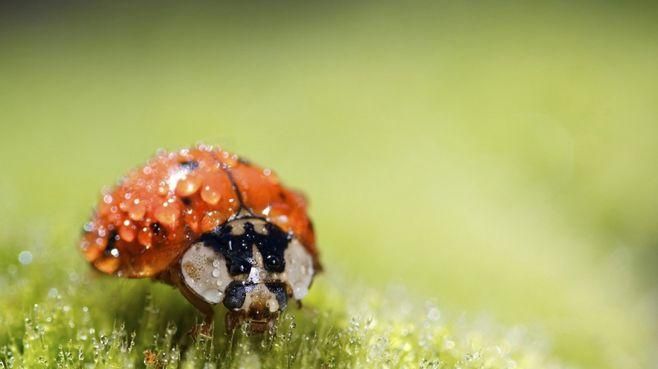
81,146,319,278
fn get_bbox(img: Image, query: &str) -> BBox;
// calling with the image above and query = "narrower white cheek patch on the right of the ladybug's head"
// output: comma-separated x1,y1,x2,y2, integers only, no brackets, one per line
283,238,314,300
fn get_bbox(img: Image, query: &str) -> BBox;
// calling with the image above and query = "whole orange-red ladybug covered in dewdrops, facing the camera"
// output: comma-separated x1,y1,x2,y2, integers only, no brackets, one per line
80,145,321,332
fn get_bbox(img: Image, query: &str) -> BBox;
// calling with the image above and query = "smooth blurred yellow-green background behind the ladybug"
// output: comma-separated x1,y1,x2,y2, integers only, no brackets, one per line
0,1,658,368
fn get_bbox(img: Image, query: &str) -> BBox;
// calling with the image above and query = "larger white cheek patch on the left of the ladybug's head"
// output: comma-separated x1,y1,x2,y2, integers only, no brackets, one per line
181,242,233,304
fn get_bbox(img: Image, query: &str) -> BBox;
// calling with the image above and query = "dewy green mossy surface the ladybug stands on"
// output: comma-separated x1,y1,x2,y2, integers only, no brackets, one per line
0,250,559,369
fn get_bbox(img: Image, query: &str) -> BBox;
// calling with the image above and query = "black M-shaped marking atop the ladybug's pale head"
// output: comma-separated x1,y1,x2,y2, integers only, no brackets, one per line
201,220,290,275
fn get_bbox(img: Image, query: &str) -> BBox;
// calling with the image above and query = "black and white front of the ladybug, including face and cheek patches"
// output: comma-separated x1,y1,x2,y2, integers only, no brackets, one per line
181,217,314,331
